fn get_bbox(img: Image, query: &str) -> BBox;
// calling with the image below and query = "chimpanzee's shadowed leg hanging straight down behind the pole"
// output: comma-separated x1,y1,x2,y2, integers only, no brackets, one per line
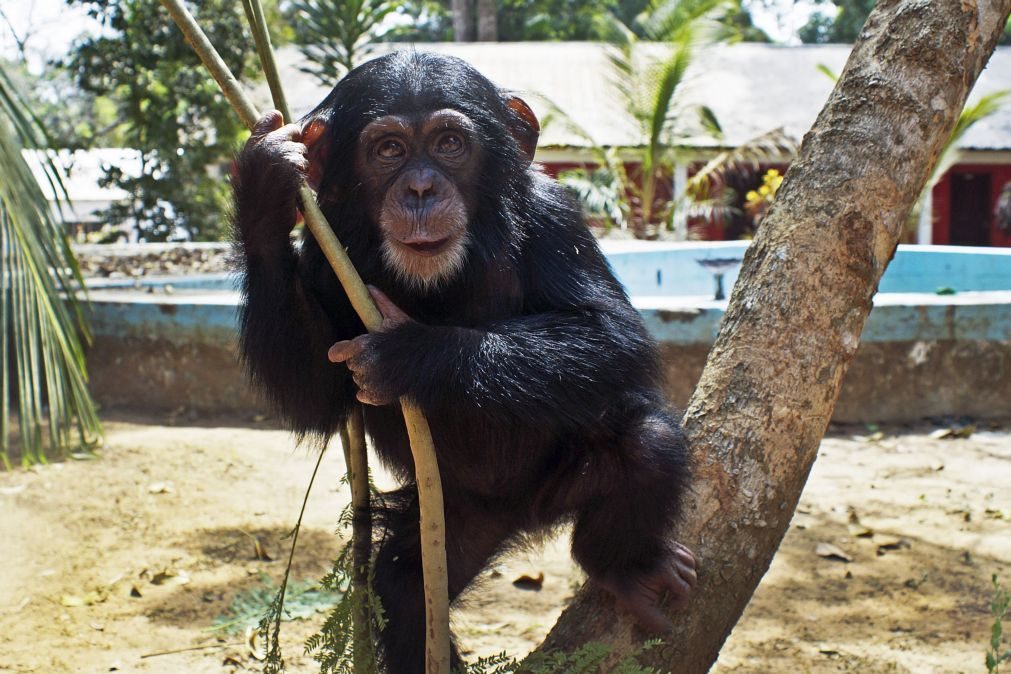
373,487,513,674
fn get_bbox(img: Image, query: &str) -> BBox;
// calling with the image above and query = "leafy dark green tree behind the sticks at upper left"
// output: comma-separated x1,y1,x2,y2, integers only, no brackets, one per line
63,0,264,240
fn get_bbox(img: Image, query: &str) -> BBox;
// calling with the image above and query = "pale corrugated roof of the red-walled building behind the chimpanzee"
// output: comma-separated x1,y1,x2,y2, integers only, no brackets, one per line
256,42,1011,151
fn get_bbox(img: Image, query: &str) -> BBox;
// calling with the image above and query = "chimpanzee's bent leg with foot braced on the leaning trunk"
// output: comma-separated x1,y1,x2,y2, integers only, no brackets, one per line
572,404,696,632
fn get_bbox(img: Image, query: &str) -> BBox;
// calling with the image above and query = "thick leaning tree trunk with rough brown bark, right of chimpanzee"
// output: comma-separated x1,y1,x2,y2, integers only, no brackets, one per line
525,0,1011,673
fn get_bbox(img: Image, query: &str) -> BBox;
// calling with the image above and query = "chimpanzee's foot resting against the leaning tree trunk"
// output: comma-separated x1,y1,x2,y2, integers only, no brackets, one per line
594,543,698,634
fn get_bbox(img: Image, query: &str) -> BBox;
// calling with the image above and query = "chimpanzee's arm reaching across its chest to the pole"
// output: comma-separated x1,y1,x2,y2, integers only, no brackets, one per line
342,224,657,430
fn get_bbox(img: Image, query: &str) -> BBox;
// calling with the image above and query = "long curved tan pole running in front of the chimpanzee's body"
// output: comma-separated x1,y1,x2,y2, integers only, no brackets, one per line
161,0,450,674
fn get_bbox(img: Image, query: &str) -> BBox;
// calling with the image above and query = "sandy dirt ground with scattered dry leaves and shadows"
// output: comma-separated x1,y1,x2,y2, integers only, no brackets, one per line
0,418,1011,674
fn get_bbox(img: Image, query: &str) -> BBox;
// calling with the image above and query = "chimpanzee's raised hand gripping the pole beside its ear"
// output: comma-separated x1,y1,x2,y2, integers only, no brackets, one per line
237,110,323,253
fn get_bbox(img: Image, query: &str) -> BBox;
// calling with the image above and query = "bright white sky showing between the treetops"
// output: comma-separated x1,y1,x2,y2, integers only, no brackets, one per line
0,0,815,72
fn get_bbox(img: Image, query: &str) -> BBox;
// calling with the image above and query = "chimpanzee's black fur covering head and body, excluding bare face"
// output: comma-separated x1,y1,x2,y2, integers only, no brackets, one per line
236,53,690,674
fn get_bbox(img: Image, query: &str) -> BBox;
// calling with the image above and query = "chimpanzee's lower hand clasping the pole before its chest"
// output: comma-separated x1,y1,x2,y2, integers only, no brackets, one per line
327,286,412,405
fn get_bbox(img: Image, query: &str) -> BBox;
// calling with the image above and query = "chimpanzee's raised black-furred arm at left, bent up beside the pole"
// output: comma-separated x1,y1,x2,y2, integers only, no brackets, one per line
234,114,364,436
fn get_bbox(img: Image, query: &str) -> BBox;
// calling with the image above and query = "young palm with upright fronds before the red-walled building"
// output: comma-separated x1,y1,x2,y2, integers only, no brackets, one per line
559,0,793,237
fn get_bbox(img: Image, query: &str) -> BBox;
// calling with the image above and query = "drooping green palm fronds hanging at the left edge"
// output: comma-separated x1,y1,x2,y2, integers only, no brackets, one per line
0,67,101,468
